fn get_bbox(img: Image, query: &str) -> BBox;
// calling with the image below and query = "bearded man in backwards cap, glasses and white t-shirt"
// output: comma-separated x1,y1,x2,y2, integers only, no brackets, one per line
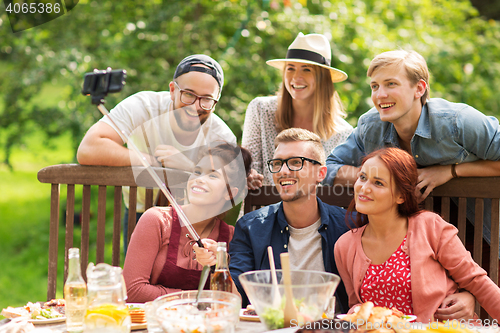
77,54,236,251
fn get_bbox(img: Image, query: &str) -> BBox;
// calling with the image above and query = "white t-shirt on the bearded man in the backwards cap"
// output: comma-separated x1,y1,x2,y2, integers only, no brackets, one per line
100,91,236,212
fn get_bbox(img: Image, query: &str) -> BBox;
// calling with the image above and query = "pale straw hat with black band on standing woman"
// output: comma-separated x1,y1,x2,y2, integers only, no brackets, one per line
266,32,347,83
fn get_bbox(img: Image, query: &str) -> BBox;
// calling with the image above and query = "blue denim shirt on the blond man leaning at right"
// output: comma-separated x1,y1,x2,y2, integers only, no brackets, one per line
323,98,500,184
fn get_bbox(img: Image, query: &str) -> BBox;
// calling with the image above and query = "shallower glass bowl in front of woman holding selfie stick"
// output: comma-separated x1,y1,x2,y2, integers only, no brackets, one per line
153,290,241,333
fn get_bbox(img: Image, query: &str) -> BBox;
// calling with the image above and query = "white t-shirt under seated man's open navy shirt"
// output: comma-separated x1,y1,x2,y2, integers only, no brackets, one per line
288,218,325,272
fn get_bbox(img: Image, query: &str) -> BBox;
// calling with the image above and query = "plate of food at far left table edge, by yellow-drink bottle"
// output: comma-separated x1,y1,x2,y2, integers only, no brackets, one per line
1,299,66,325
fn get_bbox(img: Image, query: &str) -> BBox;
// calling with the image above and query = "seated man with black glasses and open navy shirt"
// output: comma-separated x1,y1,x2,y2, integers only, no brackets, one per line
229,128,348,311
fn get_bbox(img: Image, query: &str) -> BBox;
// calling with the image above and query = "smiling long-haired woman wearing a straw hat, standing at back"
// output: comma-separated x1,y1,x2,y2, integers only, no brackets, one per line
242,33,352,189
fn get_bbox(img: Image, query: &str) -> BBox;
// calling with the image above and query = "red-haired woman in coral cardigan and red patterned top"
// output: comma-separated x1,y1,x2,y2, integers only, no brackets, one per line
335,148,500,322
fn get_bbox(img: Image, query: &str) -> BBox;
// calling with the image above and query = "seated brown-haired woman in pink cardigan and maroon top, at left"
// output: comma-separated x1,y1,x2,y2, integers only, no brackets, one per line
123,144,251,303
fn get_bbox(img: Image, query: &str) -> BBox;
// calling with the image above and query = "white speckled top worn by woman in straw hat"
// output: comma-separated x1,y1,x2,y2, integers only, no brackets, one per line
241,96,353,185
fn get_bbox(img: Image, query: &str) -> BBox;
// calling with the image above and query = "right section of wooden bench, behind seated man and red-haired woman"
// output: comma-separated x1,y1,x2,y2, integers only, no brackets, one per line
244,177,500,313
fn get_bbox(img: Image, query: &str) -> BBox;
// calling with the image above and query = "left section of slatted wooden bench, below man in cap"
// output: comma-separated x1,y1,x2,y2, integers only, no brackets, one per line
38,164,187,300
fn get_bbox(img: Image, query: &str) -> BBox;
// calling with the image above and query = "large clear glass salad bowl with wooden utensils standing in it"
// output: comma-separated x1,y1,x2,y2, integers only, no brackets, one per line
239,269,340,330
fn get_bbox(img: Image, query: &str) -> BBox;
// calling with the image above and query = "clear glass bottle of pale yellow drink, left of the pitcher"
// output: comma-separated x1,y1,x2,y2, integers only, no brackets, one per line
64,248,87,332
